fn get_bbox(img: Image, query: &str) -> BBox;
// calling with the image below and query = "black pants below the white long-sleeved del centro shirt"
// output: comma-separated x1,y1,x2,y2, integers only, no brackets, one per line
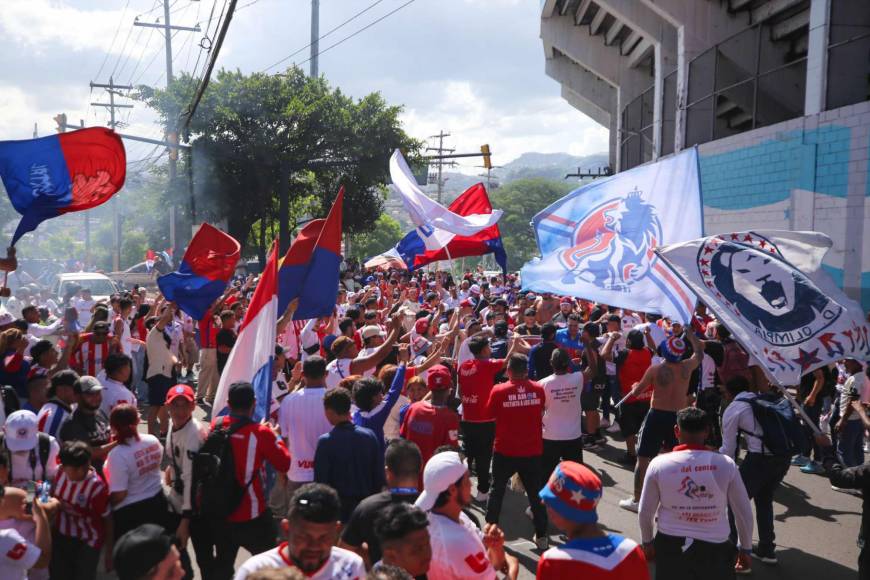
654,532,737,580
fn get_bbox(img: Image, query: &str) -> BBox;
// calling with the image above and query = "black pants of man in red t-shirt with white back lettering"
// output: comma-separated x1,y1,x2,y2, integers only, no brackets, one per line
486,453,547,537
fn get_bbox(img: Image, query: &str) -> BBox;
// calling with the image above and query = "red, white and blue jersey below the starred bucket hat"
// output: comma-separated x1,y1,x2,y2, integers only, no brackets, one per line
536,534,650,580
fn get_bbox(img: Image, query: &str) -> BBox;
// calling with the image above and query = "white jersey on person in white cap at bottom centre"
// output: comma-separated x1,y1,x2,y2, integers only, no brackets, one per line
426,512,496,580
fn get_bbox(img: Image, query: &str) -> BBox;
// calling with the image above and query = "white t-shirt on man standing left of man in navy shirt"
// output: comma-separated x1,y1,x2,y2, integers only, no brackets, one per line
278,387,332,482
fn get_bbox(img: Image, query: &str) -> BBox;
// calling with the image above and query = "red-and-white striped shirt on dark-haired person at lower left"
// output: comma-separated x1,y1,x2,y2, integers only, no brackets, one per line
54,468,110,549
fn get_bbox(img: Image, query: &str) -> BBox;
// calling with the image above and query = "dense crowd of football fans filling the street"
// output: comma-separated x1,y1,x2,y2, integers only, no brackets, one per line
0,266,870,580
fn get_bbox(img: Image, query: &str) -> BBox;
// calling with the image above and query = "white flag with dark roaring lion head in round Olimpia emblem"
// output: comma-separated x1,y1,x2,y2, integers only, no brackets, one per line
657,230,870,385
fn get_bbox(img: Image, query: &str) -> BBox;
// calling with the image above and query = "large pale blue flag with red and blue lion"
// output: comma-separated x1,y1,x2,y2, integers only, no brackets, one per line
521,148,703,324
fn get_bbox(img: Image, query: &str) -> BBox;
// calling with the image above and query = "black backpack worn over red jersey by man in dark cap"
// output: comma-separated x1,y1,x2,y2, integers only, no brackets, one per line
191,420,256,520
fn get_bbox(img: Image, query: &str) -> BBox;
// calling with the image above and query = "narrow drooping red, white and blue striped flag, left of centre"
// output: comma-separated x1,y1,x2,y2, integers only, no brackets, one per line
213,241,278,421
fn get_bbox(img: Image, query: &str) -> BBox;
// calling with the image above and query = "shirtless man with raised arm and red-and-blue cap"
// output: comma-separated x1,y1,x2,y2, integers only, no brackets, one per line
619,330,704,512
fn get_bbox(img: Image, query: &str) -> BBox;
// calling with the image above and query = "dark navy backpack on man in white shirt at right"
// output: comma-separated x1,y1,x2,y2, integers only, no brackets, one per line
741,393,806,457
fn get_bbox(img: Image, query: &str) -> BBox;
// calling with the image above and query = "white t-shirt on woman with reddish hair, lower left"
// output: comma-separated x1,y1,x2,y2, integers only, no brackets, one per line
103,434,163,510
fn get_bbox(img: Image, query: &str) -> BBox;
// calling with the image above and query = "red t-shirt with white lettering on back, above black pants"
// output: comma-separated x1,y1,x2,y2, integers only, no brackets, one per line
486,380,540,457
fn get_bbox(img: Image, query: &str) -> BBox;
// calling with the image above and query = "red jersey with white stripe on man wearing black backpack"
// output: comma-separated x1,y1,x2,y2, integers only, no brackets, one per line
212,415,290,522
